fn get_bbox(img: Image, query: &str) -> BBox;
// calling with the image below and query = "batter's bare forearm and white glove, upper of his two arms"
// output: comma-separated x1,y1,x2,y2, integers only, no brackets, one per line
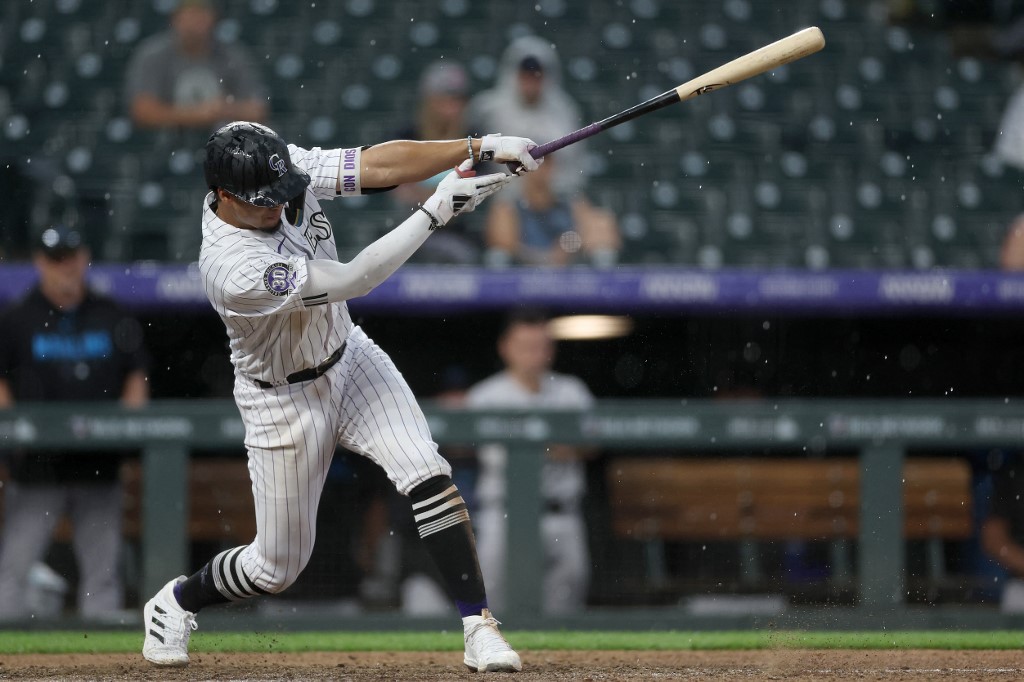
354,135,541,193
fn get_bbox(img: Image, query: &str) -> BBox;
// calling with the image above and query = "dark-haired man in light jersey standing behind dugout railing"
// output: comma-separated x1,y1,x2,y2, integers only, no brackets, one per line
466,312,594,614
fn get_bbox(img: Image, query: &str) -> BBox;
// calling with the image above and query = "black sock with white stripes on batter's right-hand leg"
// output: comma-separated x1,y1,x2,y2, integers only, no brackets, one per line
409,476,487,617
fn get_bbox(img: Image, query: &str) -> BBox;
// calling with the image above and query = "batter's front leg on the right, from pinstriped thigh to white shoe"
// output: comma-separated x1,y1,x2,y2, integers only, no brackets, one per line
339,328,522,672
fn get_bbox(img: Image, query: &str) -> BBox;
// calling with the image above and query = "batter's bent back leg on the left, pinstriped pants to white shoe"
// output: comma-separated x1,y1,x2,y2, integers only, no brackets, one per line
143,372,340,665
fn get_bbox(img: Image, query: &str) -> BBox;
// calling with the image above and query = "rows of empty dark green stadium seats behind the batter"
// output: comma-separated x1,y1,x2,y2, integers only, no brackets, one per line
0,0,1024,267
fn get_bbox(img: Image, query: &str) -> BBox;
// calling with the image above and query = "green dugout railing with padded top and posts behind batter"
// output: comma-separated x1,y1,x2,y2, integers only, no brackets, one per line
0,399,1024,629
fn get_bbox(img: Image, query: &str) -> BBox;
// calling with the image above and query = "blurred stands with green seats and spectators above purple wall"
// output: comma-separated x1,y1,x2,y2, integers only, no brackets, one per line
0,0,1024,268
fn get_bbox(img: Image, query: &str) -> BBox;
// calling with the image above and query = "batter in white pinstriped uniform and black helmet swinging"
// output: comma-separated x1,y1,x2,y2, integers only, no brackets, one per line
142,122,538,672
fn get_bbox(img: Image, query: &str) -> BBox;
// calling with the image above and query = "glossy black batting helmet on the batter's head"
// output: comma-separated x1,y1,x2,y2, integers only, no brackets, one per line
203,121,309,208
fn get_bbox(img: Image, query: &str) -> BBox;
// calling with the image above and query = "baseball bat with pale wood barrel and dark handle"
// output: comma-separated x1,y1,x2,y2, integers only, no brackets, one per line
529,26,825,159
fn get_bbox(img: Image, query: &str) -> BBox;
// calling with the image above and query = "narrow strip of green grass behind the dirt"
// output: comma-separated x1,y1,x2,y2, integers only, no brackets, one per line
0,631,1024,654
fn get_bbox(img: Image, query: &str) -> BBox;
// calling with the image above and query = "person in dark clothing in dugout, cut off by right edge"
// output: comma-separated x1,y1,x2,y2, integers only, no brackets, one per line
981,458,1024,613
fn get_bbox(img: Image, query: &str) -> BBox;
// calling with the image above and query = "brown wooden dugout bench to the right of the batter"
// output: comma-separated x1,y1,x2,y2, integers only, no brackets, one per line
605,456,974,589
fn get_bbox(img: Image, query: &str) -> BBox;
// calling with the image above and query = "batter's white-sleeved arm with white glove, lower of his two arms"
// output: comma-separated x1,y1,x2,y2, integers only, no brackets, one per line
301,164,512,302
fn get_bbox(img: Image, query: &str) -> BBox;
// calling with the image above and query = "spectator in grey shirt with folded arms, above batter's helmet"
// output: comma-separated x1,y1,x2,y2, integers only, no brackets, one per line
126,0,267,134
